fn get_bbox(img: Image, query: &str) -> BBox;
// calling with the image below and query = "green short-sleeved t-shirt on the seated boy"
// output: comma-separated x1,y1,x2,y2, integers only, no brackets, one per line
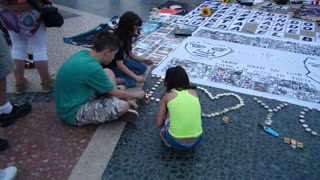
53,50,114,124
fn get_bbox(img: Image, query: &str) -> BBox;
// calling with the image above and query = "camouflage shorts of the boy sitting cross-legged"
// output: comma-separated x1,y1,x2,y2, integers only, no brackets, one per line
75,97,121,125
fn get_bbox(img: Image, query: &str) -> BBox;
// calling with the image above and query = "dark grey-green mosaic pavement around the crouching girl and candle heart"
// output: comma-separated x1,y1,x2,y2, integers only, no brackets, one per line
102,72,320,179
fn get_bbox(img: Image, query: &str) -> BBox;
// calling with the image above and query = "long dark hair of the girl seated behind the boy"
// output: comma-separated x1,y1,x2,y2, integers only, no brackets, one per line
114,11,142,51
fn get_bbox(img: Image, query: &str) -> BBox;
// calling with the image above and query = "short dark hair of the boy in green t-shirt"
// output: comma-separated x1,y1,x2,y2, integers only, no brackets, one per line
92,31,122,52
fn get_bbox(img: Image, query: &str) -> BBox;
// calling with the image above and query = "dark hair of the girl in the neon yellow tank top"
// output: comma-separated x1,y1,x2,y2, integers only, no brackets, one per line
164,66,196,92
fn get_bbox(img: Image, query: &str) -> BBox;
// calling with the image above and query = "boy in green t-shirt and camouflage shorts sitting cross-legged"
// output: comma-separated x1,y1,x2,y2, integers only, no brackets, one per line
53,31,145,125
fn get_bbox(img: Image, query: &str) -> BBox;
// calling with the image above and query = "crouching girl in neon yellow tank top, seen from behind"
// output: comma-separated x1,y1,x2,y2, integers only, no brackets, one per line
157,66,202,150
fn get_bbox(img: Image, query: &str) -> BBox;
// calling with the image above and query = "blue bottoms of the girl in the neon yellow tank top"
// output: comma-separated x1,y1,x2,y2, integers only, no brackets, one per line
163,119,202,150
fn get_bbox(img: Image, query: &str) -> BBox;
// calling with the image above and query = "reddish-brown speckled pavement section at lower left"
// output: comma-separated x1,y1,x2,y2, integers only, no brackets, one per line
0,102,97,180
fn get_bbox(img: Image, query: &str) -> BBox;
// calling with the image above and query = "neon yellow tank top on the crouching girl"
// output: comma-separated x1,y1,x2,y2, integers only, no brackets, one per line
167,89,202,138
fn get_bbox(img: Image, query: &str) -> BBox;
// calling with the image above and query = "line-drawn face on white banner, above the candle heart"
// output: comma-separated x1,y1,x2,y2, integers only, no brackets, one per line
185,41,234,60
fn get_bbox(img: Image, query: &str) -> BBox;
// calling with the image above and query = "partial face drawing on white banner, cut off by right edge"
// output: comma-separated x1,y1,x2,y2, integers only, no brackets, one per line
304,57,320,84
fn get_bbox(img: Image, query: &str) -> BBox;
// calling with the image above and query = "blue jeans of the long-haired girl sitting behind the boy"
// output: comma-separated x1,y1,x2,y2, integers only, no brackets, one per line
112,58,147,88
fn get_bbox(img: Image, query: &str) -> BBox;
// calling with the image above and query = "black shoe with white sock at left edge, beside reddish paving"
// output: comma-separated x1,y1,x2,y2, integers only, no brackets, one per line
0,103,32,127
